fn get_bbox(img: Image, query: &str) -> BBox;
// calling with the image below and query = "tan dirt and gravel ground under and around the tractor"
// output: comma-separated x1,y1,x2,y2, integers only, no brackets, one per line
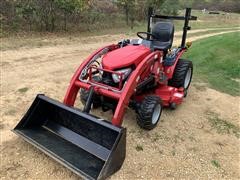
0,29,240,179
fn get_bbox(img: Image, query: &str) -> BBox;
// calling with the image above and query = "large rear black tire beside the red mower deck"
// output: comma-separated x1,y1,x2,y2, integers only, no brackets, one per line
168,59,193,90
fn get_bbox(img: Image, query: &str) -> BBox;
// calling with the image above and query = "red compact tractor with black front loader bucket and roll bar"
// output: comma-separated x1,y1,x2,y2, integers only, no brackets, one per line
13,8,197,179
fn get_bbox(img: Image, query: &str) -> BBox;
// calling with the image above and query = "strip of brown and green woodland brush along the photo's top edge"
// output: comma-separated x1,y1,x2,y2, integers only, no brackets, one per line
0,0,240,34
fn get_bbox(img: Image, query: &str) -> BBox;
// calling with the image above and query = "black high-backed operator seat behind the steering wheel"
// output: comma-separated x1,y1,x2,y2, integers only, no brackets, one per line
152,21,174,52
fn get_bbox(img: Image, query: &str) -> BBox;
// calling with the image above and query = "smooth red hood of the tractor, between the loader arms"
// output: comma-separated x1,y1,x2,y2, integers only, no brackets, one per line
102,45,151,70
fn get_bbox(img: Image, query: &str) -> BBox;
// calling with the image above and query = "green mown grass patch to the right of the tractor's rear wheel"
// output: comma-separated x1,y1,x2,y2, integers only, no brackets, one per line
184,32,240,96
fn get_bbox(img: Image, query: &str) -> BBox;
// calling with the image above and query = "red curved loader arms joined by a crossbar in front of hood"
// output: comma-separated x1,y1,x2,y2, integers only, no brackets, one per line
64,45,161,127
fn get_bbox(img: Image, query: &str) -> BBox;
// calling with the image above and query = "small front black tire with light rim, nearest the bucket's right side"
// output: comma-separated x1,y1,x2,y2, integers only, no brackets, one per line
137,95,162,130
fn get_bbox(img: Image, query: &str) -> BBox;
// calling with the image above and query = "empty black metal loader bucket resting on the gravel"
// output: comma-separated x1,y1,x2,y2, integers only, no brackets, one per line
13,95,126,179
